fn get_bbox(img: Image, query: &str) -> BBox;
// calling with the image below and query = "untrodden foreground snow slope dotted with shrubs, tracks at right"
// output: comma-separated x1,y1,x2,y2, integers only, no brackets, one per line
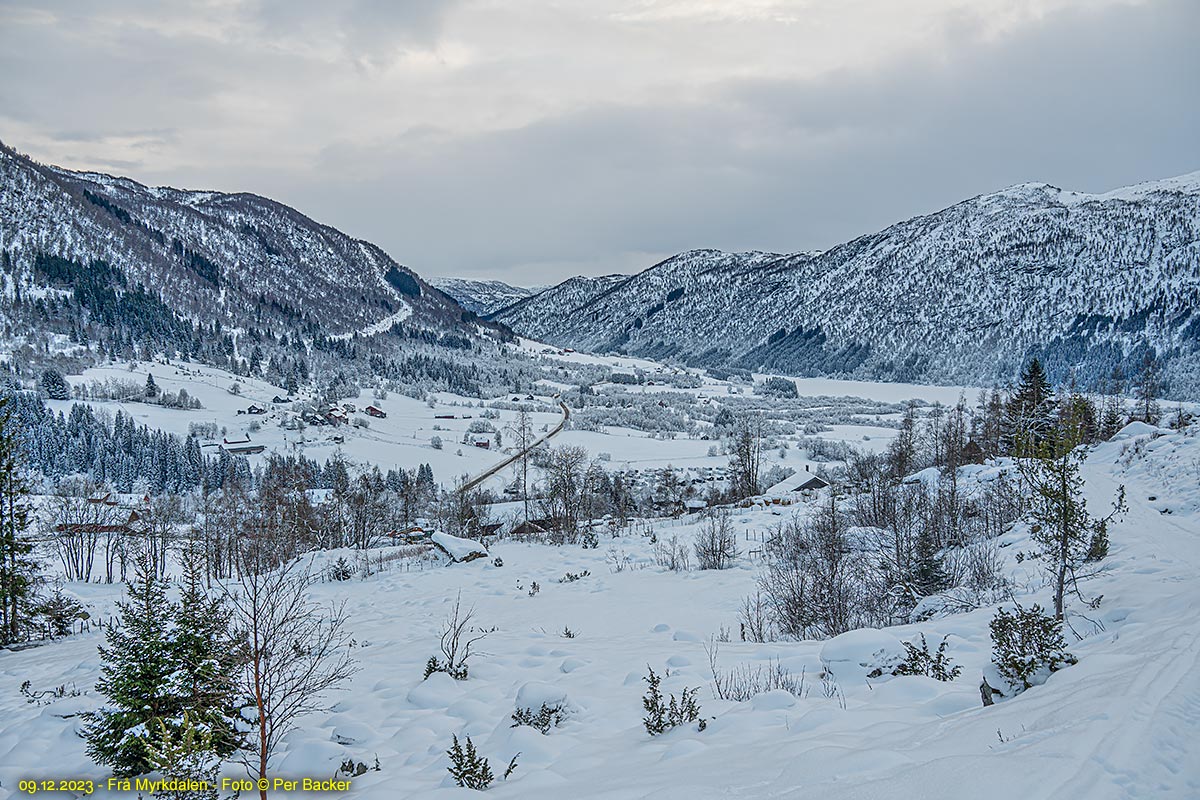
0,424,1200,800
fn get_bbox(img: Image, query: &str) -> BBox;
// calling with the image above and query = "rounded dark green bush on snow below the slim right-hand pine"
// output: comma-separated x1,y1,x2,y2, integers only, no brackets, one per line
990,604,1079,692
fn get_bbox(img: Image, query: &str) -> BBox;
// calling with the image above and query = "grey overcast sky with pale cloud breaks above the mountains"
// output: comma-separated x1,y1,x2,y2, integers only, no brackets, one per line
0,0,1200,284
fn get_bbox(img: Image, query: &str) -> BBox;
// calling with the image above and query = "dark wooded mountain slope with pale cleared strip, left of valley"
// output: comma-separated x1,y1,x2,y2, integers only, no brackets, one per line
0,145,475,336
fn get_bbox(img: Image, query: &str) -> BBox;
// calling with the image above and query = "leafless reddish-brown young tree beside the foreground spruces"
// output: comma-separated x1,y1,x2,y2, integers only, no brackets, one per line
228,561,358,800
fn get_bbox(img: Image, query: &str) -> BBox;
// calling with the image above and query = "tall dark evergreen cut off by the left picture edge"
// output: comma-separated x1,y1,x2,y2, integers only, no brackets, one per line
0,397,37,643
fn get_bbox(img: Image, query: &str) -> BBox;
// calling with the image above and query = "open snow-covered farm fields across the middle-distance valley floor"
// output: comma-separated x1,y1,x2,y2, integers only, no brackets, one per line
39,350,945,491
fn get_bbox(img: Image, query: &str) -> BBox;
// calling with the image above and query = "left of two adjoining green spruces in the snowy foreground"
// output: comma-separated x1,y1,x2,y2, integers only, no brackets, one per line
83,553,180,776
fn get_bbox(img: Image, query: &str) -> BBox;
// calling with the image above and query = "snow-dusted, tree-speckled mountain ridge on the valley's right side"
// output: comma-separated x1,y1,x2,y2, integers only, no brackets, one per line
493,173,1200,397
